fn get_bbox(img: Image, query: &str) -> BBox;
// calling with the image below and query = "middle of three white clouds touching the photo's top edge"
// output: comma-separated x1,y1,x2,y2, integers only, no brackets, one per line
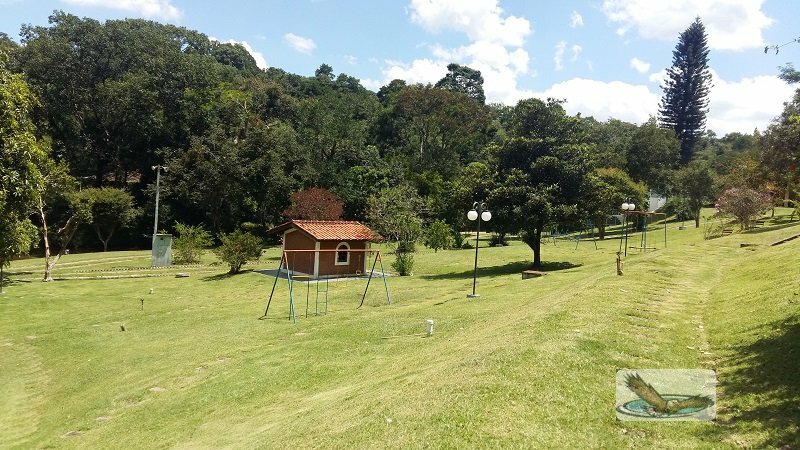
410,0,531,47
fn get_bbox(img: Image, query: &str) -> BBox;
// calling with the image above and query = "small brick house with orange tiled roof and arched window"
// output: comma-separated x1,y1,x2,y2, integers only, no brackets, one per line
269,220,381,278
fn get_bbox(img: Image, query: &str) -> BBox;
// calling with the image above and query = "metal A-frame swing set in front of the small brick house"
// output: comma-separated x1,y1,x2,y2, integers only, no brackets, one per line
259,249,392,323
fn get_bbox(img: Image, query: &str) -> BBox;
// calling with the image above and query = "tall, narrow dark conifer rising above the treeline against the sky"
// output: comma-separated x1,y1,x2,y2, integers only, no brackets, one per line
658,17,711,164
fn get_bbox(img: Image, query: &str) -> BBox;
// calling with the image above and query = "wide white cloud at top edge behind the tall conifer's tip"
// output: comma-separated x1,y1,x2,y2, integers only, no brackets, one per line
603,0,773,50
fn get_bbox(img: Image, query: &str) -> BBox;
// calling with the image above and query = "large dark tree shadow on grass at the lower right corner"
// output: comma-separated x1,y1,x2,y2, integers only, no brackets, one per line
709,316,800,448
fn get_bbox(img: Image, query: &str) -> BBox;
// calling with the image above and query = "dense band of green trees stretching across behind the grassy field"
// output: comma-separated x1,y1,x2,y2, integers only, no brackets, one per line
0,12,800,263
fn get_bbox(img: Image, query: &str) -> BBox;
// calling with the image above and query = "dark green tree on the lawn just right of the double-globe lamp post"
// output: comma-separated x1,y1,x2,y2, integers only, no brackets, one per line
492,99,592,267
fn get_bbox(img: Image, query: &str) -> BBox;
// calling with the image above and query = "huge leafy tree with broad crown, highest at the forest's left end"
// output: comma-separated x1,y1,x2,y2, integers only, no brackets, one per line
17,11,219,187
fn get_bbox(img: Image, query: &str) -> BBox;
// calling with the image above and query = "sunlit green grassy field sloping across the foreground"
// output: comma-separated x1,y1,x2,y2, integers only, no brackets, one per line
0,211,800,448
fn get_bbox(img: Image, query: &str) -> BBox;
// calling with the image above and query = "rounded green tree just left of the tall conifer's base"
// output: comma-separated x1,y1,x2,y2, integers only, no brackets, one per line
626,118,680,193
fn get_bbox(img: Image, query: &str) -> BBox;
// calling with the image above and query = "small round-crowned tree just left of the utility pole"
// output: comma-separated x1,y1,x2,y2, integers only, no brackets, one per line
75,188,139,252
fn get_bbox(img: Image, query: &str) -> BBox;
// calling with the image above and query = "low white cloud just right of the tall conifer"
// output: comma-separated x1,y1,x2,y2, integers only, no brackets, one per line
706,70,794,135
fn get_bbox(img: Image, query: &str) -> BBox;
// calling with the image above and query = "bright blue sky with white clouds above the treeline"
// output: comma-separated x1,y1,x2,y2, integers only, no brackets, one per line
0,0,800,135
